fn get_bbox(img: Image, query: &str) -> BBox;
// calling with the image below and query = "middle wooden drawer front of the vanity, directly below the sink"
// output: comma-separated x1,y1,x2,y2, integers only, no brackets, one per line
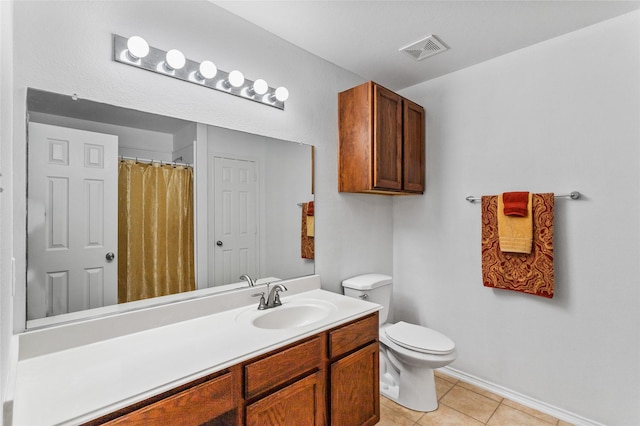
244,336,323,399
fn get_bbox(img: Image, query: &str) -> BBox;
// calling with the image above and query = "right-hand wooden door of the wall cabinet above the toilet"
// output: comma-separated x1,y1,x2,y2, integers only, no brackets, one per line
403,99,425,193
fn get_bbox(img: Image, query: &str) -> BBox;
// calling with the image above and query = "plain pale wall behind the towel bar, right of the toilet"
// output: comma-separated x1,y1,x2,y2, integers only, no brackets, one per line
393,12,640,425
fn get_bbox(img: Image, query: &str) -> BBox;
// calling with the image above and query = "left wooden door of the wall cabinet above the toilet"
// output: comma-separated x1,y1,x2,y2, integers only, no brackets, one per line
373,85,402,190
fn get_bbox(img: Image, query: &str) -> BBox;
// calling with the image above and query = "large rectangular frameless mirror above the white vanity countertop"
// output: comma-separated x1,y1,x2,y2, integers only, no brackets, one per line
26,88,314,328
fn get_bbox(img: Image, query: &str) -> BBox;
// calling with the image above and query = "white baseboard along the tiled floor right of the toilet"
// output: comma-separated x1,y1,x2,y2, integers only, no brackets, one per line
438,367,605,426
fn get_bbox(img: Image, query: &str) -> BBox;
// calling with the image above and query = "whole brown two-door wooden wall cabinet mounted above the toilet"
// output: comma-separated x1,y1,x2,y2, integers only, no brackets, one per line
338,81,425,195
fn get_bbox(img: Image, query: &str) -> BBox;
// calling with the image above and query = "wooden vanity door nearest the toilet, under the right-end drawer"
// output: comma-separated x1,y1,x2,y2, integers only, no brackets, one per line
330,342,380,425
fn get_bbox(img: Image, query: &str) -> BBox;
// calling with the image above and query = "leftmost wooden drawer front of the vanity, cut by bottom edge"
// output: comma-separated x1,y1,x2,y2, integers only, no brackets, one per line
101,373,238,425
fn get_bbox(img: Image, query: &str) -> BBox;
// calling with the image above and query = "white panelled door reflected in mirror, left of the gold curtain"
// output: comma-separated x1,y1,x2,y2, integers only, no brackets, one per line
27,123,118,319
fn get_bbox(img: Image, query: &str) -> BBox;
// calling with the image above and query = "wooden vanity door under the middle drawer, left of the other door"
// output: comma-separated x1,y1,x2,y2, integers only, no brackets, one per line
246,372,324,426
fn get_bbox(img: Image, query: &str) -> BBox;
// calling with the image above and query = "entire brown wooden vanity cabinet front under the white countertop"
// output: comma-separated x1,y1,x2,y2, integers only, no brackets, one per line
85,312,380,426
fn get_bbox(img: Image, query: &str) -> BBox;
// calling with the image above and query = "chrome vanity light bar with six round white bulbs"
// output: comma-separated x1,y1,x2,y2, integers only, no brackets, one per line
113,34,289,110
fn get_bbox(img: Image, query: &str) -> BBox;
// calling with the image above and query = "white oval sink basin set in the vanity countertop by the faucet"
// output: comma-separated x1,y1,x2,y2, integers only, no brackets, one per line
237,299,337,329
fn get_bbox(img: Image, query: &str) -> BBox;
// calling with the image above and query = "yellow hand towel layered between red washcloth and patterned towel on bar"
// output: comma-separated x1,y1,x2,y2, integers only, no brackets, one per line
497,193,533,253
